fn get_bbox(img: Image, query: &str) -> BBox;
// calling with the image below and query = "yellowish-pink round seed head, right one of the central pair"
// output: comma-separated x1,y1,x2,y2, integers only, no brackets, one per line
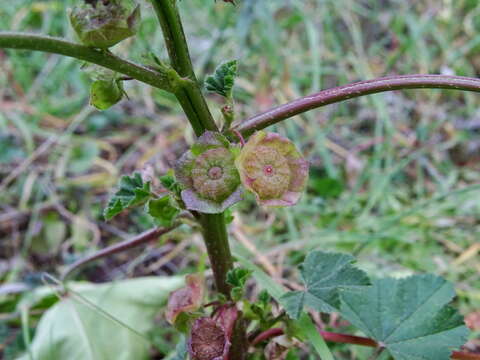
236,131,309,206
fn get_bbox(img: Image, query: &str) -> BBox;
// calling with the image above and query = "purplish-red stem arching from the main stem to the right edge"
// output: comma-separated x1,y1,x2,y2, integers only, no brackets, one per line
233,75,480,136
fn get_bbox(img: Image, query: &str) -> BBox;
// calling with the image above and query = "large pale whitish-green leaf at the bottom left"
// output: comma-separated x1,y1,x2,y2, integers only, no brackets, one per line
18,276,183,360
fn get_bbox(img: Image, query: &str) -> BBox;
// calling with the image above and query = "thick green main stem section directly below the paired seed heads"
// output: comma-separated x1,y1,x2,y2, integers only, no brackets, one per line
200,214,233,299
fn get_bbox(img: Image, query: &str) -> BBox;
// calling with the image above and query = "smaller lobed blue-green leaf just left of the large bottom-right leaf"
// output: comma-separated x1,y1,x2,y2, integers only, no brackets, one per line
280,251,370,319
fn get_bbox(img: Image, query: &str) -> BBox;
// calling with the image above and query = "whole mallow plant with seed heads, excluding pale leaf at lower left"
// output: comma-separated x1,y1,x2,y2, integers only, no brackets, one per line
0,0,480,360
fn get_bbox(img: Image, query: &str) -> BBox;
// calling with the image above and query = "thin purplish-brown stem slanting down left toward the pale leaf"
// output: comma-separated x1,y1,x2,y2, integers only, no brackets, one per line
61,225,178,281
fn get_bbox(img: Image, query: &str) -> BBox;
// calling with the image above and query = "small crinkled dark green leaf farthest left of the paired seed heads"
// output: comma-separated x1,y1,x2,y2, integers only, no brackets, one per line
103,173,151,220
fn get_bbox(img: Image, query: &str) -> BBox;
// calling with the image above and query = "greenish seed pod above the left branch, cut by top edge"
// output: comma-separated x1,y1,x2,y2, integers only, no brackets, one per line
69,0,140,49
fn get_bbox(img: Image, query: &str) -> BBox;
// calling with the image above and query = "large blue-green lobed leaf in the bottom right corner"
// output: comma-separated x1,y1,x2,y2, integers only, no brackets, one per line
341,275,468,360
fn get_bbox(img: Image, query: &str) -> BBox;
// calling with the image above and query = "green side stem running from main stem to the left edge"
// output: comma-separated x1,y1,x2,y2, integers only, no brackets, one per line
0,31,173,92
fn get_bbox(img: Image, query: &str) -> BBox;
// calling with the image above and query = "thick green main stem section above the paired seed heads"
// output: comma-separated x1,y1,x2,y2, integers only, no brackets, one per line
152,0,218,136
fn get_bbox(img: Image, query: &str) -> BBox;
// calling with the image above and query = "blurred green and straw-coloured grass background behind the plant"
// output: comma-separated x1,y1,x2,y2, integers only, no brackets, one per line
0,0,480,359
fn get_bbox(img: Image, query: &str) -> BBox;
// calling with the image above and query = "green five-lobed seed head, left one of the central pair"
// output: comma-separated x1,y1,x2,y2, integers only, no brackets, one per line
175,131,242,214
